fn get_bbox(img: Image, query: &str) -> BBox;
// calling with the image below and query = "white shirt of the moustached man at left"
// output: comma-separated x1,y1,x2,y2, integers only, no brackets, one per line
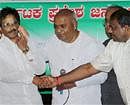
0,36,43,105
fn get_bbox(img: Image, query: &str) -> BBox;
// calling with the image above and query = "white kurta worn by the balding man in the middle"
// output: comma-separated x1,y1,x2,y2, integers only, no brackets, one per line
43,32,107,105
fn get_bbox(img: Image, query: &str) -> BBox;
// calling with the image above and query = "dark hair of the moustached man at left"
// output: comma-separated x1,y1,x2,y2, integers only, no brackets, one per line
0,7,20,27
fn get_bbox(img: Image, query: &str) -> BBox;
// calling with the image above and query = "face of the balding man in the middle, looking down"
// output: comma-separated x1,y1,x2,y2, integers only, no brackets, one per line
54,15,75,43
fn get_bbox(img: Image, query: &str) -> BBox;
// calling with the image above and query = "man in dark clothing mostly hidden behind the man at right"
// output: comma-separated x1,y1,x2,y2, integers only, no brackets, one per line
101,6,124,105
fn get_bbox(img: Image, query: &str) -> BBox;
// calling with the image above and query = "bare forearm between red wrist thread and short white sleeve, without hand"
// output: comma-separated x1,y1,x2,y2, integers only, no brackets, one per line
60,63,99,84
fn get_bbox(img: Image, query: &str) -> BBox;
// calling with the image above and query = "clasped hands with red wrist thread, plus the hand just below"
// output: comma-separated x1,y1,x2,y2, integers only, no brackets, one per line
33,76,76,91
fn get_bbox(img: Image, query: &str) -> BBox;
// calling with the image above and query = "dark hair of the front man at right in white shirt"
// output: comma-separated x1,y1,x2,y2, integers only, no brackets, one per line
110,9,130,27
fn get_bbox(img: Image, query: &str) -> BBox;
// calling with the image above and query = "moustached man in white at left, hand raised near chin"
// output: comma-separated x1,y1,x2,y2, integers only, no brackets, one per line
0,7,43,105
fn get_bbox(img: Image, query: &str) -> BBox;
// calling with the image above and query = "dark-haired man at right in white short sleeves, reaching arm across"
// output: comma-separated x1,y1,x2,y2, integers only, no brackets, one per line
43,9,130,105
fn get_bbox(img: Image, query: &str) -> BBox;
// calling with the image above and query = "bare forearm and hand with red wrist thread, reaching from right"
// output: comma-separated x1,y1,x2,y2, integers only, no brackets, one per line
41,63,99,88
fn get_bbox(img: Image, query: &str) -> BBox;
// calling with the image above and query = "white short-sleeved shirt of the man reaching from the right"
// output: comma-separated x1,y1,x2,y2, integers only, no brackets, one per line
91,40,130,105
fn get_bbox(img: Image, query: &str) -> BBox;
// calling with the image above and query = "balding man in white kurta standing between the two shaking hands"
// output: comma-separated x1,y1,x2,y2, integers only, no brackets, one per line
36,9,107,105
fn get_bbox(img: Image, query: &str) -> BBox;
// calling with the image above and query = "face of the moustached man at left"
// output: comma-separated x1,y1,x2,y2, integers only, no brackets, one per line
1,15,19,39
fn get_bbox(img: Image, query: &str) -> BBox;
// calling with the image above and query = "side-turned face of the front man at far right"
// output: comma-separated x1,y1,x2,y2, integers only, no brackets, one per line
110,19,128,42
